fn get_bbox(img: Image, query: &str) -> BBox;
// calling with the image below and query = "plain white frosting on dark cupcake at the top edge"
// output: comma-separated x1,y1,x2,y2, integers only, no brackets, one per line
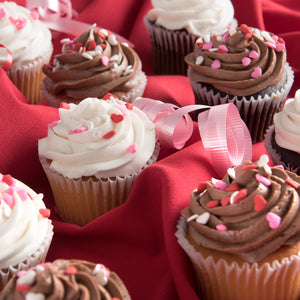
147,0,236,35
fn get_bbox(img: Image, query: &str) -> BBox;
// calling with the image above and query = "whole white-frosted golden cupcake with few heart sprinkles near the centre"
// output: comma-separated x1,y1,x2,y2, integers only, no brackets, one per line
38,97,159,225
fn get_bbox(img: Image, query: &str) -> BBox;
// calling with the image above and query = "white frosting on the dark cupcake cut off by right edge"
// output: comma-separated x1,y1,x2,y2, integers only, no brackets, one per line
274,89,300,153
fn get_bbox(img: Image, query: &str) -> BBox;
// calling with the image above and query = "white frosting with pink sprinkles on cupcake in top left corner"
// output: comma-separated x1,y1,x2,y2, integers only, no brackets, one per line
0,1,52,67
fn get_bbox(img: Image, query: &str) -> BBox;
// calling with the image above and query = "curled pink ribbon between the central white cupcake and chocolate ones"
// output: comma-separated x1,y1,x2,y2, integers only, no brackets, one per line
133,97,252,177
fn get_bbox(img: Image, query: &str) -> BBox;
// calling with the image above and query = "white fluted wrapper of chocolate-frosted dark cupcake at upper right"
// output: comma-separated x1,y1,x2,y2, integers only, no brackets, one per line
188,63,294,143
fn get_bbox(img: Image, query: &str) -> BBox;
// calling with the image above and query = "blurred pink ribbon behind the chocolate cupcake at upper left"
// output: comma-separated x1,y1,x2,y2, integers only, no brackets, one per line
26,0,134,47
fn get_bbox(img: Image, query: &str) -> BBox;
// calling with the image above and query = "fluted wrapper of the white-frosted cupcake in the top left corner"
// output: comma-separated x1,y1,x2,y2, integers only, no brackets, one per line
6,48,53,104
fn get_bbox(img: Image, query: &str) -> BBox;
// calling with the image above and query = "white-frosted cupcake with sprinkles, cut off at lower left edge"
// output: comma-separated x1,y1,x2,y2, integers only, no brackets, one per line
0,174,53,290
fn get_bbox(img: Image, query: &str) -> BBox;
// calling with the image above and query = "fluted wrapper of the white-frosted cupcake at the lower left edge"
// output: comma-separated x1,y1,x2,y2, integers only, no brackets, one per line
0,220,53,290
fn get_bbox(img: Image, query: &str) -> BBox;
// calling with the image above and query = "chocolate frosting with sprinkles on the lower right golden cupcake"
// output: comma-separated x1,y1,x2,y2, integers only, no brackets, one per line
182,155,300,262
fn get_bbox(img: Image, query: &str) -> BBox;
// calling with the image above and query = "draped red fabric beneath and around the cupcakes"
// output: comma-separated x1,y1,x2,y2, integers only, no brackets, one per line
0,0,300,300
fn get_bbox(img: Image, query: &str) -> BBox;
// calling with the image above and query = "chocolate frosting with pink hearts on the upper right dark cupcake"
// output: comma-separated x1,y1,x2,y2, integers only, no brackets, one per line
185,24,286,96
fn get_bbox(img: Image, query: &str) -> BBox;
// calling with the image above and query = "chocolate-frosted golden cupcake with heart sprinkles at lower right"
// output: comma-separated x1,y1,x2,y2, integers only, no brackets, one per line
176,155,300,300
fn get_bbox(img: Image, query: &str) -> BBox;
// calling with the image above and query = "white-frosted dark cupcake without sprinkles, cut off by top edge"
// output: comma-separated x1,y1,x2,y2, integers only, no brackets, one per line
144,0,237,76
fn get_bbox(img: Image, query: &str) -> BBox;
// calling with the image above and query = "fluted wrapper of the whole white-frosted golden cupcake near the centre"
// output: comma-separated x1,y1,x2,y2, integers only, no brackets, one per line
40,144,160,226
